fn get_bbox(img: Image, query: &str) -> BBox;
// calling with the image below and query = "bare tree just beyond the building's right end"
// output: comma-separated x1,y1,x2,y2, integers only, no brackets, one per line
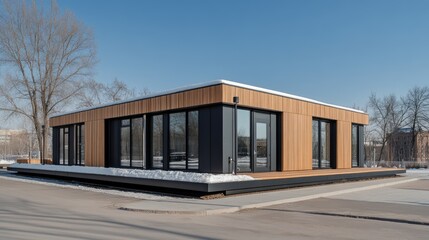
368,93,408,161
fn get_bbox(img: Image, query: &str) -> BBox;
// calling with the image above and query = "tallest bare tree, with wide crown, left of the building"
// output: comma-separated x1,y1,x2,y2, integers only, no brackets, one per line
0,0,95,160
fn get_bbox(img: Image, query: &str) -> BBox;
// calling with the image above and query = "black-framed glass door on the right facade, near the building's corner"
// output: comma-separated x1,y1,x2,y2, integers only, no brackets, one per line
253,112,271,172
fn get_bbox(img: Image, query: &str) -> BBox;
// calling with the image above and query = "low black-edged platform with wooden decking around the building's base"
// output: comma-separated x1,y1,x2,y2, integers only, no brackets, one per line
8,167,405,195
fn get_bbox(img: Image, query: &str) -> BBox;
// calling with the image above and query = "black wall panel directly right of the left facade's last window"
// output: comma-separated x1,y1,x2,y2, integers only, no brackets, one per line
198,108,211,172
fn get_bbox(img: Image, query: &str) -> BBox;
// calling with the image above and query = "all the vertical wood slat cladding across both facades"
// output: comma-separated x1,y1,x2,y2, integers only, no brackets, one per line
50,84,368,171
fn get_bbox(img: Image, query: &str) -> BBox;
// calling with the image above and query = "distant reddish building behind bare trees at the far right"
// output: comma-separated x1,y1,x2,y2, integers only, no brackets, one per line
387,128,429,162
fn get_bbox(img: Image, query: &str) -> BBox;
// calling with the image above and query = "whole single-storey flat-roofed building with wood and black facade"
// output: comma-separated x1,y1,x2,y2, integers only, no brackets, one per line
50,80,368,173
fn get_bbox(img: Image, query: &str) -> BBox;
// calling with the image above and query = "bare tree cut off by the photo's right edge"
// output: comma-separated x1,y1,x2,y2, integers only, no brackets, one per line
403,87,429,157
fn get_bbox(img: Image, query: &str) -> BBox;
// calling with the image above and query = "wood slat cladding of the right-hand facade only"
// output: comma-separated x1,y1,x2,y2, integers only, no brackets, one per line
223,85,368,171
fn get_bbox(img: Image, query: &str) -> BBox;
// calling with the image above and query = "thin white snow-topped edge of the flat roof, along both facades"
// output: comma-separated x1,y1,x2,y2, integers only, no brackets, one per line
51,79,365,118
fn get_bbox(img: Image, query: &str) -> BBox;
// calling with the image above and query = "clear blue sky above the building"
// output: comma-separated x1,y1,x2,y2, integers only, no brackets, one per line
58,0,429,109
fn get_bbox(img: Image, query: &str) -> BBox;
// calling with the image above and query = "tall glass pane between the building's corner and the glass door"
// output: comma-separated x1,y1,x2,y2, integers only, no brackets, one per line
237,109,252,172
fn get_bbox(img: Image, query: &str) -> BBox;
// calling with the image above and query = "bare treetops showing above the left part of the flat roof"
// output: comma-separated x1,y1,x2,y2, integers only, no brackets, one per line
78,78,150,107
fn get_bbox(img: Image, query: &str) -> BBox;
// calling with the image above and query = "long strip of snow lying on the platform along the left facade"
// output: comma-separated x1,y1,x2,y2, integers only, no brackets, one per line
11,163,254,183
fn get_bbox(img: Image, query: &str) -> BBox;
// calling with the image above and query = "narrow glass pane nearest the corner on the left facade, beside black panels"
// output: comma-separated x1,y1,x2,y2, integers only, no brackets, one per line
188,111,199,170
